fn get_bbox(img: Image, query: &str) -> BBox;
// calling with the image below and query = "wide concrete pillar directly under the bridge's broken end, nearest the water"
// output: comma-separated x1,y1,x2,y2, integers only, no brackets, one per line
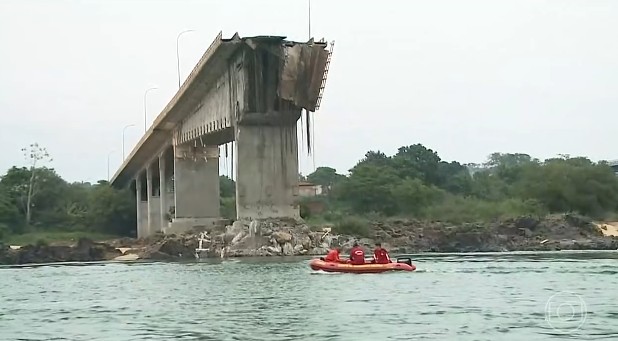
236,122,300,219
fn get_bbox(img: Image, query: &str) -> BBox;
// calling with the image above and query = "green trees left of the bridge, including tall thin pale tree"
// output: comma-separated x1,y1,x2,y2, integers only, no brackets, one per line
0,144,136,242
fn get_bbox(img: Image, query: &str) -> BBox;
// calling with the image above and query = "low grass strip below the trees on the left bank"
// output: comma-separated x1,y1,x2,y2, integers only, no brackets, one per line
3,231,120,246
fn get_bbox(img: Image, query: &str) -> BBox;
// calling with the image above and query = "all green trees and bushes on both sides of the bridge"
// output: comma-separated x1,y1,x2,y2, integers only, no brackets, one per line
0,144,618,240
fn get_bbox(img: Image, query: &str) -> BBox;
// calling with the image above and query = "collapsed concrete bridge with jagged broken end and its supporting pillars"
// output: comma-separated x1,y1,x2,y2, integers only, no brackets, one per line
111,33,332,238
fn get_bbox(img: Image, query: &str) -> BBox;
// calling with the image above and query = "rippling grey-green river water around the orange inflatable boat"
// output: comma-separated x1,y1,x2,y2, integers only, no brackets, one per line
0,252,618,341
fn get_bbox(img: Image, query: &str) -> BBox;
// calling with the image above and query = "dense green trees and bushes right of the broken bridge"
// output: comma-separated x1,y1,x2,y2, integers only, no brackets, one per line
308,144,618,223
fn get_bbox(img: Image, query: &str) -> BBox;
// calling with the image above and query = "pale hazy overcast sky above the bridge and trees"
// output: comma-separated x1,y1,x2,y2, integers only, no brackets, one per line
0,0,618,181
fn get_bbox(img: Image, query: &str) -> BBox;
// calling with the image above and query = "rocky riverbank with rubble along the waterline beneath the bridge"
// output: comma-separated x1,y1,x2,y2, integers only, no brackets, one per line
0,215,618,264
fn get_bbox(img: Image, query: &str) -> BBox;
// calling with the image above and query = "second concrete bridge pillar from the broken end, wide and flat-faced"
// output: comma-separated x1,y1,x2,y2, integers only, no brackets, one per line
170,145,220,233
